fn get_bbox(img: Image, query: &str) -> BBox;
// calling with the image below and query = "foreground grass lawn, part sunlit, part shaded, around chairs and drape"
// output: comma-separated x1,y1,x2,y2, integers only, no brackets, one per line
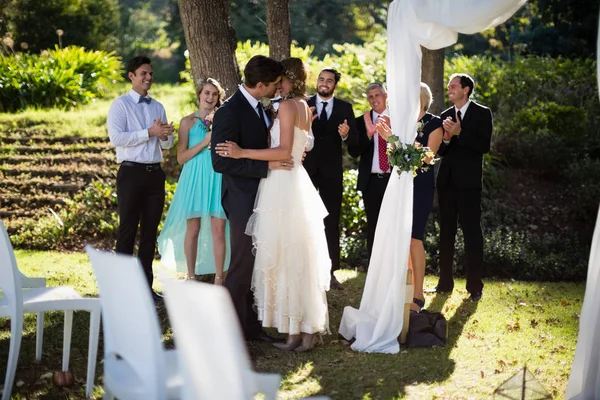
0,251,585,400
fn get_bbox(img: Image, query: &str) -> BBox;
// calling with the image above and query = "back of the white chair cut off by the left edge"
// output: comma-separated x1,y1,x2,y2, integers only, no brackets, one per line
0,221,23,318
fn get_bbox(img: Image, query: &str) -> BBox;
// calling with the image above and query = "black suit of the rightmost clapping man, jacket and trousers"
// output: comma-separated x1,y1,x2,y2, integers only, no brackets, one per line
437,102,493,293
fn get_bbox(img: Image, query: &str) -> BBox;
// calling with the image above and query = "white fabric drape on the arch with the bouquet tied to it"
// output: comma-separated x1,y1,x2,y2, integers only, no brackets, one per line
339,0,526,353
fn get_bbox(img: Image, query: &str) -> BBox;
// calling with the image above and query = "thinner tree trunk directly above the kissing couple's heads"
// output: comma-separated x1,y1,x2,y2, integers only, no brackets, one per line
267,0,292,61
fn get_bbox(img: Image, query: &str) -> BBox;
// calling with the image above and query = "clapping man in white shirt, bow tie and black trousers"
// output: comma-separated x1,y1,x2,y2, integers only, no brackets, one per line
107,56,174,300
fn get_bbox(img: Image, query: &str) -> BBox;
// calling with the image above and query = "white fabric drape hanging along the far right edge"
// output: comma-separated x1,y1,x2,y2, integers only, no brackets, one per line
565,12,600,400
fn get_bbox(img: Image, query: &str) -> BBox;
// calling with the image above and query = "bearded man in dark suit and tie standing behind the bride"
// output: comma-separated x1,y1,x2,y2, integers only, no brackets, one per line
304,68,358,289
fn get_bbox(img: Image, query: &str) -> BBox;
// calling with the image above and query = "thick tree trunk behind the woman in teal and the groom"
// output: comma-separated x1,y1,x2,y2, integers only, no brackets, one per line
178,0,241,96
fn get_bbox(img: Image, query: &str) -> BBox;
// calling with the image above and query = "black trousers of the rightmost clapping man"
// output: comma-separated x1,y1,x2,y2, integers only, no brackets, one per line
438,186,483,293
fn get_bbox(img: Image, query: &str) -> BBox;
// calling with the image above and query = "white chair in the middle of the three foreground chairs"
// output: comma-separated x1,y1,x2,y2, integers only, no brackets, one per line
85,245,183,400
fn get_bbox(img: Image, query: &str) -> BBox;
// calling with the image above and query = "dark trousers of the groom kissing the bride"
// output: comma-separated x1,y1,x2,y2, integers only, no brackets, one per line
222,193,262,339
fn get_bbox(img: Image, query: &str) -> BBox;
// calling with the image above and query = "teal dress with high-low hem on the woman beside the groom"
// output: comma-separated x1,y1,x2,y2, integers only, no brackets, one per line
158,114,230,275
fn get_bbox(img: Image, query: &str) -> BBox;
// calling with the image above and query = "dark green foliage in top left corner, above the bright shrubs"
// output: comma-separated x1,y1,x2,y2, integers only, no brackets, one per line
0,0,119,53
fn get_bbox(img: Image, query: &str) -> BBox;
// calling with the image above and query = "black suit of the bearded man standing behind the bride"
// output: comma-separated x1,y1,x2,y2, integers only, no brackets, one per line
304,96,358,272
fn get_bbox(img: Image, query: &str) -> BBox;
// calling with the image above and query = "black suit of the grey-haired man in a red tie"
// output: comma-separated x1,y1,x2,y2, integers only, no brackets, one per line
348,110,390,258
